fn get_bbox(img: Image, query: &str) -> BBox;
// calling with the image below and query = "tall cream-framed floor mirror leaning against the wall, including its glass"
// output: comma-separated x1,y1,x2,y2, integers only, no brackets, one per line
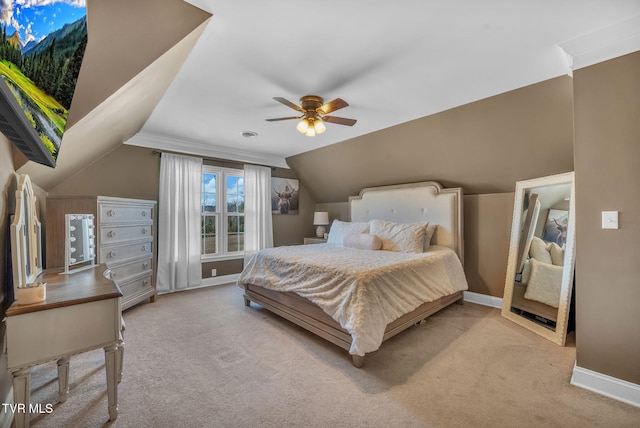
502,172,575,346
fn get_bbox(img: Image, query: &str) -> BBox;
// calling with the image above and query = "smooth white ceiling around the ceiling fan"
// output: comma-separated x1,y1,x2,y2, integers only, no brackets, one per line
126,0,640,166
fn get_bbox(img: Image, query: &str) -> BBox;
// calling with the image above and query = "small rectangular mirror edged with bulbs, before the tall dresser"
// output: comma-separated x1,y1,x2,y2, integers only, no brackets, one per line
65,214,95,273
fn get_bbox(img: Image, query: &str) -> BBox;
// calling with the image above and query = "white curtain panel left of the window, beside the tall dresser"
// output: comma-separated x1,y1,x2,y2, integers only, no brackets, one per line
156,153,202,293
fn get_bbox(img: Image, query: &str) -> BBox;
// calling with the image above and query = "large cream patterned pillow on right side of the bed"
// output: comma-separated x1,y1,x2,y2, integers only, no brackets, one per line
369,220,427,253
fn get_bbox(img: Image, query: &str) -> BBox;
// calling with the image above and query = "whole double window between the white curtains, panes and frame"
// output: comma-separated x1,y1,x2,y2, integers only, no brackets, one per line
201,165,244,258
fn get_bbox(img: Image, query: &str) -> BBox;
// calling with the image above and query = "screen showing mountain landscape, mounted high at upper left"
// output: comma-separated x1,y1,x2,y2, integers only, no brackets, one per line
0,0,87,167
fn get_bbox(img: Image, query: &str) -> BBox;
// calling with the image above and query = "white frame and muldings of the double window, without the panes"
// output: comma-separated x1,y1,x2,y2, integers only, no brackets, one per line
200,165,245,262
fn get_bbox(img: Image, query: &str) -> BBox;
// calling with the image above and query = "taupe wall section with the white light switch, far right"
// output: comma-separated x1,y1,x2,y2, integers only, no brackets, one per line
574,52,640,384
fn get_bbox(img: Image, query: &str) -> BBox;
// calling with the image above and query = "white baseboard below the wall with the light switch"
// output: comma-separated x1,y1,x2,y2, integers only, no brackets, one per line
571,365,640,407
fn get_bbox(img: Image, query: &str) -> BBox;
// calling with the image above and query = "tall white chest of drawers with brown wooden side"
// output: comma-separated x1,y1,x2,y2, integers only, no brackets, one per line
45,196,156,309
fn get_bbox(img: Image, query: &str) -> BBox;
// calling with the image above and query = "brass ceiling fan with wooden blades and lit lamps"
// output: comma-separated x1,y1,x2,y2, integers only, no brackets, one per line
266,95,356,137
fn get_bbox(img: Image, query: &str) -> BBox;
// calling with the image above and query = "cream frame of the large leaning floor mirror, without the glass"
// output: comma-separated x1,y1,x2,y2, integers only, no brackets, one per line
502,172,576,346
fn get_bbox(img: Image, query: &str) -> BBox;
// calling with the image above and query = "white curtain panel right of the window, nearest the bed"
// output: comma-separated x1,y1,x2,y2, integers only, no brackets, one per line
244,165,273,265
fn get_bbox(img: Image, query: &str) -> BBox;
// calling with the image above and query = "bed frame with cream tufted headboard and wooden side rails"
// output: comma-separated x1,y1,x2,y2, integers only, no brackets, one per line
244,181,464,367
